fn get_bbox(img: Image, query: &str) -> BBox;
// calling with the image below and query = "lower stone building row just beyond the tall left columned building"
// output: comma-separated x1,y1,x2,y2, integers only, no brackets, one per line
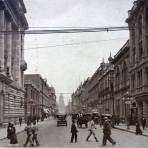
25,74,56,117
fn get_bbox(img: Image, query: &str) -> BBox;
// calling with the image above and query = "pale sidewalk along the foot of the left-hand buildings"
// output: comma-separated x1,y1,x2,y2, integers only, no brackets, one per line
0,119,51,140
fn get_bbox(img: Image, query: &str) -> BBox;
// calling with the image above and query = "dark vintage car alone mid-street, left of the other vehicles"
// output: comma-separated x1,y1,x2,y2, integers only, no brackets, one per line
57,114,67,126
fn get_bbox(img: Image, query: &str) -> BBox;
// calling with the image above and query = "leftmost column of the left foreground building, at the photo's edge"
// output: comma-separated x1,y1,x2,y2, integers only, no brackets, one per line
0,10,5,73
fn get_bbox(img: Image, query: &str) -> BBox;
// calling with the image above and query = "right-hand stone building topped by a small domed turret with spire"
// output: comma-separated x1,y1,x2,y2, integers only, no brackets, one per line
97,55,115,115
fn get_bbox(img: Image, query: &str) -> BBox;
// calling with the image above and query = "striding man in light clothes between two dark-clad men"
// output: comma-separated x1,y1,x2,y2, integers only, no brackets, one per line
86,118,98,142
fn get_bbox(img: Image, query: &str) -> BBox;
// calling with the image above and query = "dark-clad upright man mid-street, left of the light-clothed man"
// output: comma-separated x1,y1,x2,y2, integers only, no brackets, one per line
70,120,78,143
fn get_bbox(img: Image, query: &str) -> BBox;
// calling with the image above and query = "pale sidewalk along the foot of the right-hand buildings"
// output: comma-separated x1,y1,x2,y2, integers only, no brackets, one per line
114,124,148,137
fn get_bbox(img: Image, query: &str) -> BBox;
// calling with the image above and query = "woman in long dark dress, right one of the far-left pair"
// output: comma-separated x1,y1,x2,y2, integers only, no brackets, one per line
10,123,18,144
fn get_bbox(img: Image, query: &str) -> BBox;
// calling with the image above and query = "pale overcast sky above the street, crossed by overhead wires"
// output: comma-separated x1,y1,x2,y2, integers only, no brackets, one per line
24,0,133,104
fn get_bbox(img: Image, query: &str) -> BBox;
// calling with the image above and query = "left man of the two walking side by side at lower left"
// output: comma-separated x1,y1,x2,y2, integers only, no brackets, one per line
24,122,34,147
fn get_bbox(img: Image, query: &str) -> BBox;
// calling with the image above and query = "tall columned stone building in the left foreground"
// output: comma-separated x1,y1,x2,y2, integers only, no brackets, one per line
0,0,28,125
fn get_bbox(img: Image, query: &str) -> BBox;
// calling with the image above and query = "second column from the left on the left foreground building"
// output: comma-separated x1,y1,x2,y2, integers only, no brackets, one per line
6,21,12,78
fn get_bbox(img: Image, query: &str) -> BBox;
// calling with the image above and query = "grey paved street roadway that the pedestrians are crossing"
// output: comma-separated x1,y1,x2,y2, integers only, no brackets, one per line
0,119,148,148
